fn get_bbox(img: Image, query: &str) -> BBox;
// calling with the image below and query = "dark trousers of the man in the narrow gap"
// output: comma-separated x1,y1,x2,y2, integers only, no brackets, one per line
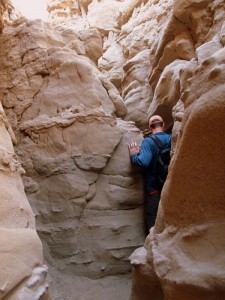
145,194,160,234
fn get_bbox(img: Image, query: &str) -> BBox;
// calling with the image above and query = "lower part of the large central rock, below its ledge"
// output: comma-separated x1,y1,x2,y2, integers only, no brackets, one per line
18,105,145,278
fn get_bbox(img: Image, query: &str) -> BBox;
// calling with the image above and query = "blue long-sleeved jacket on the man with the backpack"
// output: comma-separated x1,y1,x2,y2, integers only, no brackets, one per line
131,132,171,193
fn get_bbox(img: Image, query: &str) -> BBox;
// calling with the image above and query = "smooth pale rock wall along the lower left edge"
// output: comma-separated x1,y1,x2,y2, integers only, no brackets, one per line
0,105,48,300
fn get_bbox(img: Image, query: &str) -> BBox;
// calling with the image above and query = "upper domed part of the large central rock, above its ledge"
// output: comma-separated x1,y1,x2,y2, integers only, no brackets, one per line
2,22,126,124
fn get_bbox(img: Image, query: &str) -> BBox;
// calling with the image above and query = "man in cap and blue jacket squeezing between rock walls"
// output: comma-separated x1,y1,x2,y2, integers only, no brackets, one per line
128,115,171,234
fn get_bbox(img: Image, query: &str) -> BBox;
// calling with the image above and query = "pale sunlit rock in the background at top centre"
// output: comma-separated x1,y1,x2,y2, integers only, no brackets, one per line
45,0,175,129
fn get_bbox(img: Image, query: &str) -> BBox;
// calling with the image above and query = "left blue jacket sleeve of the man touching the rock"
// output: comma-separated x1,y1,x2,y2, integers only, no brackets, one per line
131,139,154,168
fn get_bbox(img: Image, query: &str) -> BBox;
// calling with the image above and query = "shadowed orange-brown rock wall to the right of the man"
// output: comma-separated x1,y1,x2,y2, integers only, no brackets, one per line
130,1,225,300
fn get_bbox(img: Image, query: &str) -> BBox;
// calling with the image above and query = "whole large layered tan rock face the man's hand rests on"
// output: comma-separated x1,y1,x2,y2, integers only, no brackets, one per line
0,20,144,299
